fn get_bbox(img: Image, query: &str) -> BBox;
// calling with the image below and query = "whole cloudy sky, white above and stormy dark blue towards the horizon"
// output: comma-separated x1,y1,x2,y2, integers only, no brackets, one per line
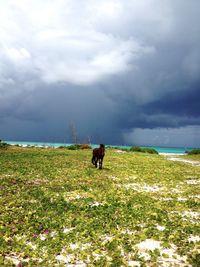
0,0,200,147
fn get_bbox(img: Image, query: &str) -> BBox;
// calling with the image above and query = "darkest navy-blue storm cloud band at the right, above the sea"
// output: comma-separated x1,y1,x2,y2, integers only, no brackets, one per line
112,80,200,129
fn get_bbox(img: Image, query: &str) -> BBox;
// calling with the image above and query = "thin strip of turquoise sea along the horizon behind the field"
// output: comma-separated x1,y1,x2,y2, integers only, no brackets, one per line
6,141,197,154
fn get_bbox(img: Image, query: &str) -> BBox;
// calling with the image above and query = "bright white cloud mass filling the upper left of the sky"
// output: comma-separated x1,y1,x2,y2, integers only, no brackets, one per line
0,0,155,85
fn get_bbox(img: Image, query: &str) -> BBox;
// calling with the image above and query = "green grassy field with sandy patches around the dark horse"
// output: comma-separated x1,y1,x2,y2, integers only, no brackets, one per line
0,147,200,267
